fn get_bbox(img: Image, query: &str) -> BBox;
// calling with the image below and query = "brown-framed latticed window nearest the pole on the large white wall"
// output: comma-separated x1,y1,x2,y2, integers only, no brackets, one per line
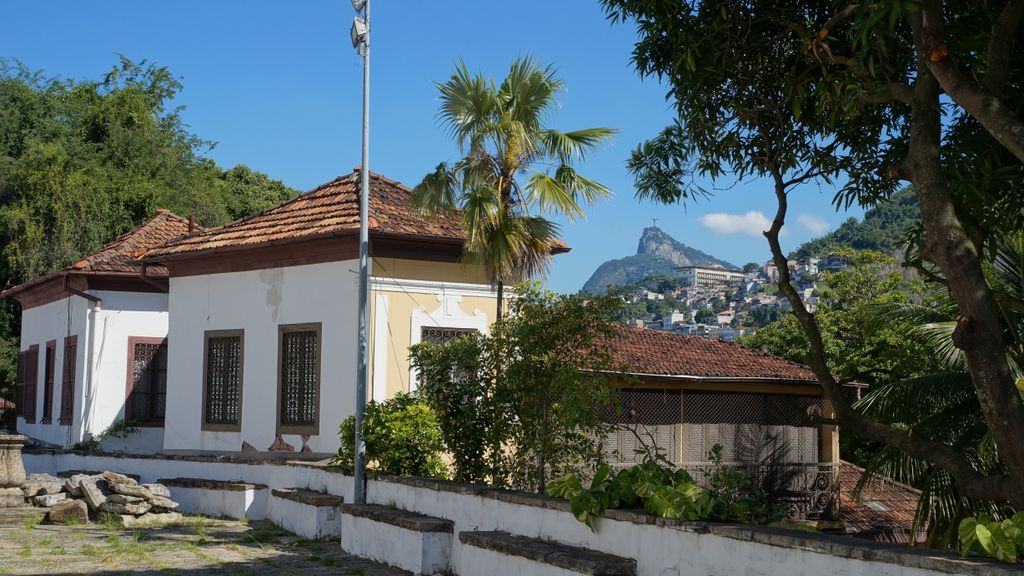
278,324,321,434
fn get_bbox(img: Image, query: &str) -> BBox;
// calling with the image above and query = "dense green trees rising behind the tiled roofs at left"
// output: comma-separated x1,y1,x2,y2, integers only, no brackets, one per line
0,57,297,392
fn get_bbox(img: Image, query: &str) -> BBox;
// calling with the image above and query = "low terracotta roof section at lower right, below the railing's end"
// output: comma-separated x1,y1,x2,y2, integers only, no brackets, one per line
839,462,921,539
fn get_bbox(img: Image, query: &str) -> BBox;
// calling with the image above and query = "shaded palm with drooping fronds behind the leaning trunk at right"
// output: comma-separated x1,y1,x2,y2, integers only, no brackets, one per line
855,231,1024,547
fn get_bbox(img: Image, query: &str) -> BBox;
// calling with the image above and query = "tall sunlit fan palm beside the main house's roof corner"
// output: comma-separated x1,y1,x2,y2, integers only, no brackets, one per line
413,58,615,320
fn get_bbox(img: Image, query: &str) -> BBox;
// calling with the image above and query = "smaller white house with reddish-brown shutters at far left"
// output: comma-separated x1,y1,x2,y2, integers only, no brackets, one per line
0,210,189,452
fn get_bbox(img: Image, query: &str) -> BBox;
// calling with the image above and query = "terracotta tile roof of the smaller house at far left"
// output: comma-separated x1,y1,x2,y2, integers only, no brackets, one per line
65,209,195,276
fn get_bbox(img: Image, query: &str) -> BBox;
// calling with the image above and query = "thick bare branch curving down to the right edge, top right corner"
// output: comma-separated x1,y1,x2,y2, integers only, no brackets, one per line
913,0,1024,162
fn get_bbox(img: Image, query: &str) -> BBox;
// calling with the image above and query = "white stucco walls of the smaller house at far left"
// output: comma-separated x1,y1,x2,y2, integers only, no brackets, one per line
18,290,167,452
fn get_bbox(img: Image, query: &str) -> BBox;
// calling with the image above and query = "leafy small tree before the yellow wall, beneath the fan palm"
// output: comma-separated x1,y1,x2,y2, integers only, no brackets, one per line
410,285,623,492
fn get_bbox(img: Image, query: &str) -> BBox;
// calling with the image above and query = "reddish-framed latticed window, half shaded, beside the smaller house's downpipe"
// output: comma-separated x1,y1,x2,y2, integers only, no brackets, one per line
125,338,167,424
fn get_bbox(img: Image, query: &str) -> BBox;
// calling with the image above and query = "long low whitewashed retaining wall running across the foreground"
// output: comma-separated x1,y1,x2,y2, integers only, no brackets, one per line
25,452,1024,576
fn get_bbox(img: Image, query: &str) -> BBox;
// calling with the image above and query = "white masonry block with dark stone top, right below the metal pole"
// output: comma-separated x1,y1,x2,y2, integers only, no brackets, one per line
341,504,455,574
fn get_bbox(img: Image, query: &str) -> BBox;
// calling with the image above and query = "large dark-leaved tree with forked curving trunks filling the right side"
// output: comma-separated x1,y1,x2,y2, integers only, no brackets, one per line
602,0,1024,506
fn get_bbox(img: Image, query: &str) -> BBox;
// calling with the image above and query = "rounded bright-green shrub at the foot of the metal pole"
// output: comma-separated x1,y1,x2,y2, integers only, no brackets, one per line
335,394,447,478
